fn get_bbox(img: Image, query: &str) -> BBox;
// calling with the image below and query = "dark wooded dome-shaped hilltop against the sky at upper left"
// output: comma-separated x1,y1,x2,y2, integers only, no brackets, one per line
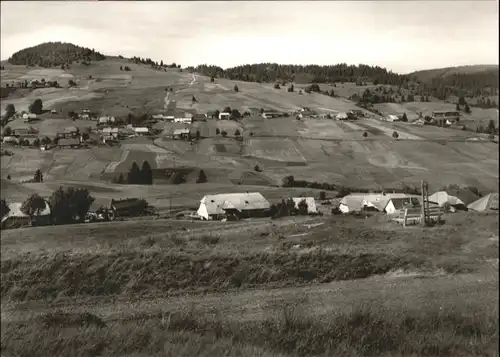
8,42,106,67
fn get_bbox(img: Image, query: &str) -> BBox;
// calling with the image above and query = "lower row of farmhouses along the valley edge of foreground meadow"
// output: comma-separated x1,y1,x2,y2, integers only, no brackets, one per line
2,186,499,227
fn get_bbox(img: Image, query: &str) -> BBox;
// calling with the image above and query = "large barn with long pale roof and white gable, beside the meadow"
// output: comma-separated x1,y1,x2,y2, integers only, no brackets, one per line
197,192,271,220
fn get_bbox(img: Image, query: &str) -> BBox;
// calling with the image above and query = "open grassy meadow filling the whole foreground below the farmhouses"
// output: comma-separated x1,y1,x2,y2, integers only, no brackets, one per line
1,213,499,357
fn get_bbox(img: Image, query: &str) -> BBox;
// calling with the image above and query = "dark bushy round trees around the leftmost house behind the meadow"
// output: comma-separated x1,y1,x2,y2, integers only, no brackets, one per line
0,187,94,224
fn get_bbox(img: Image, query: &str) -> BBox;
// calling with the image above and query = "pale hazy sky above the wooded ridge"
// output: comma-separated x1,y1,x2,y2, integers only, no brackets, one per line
0,0,499,73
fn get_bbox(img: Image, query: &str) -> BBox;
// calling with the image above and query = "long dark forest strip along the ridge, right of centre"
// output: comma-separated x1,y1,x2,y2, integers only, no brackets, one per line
188,63,410,85
